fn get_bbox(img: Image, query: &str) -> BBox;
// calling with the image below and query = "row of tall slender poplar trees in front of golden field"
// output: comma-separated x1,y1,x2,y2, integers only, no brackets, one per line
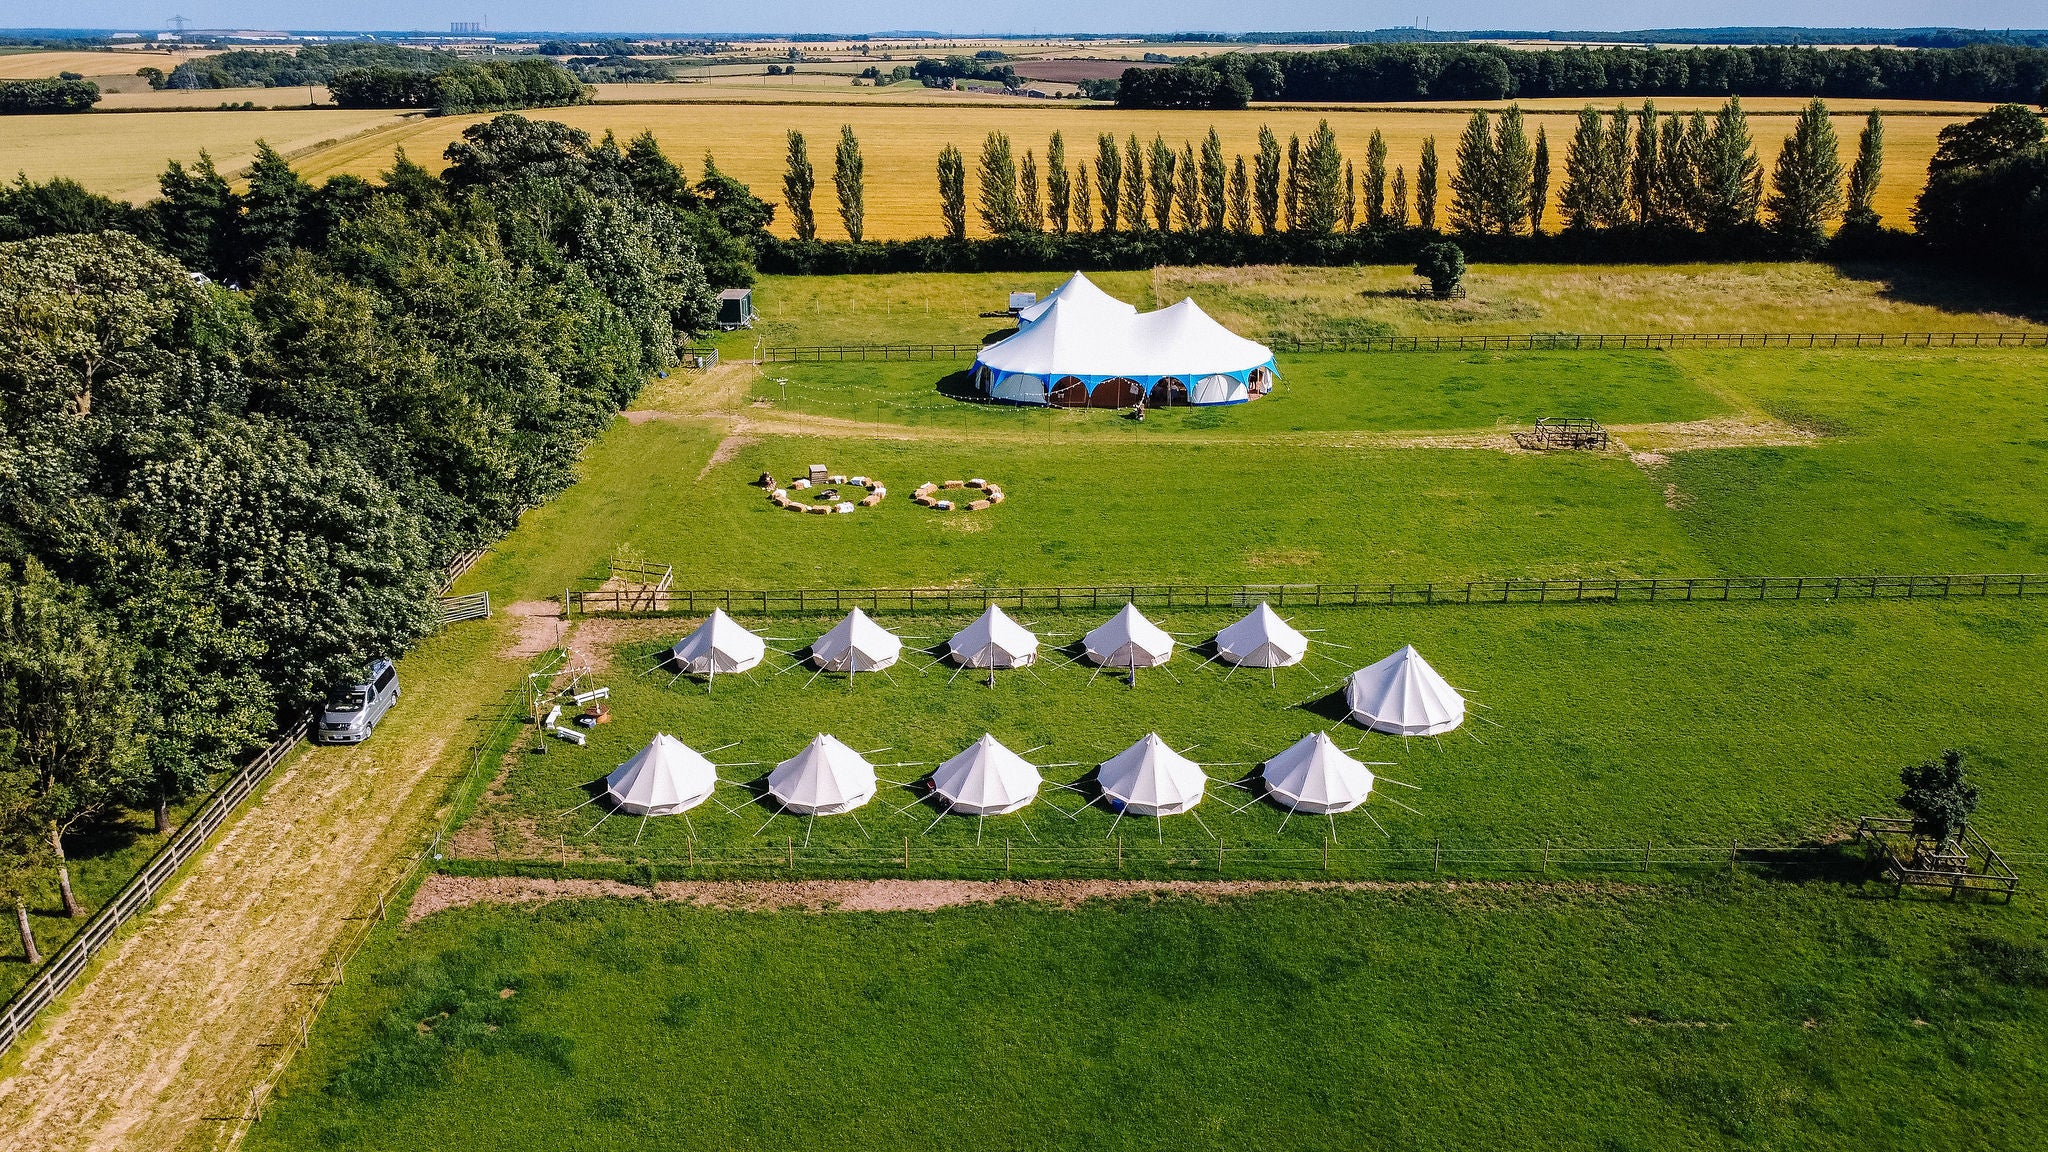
782,98,1884,246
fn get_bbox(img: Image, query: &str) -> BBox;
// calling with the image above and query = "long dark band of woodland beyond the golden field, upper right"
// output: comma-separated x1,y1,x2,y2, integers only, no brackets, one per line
1116,43,2048,109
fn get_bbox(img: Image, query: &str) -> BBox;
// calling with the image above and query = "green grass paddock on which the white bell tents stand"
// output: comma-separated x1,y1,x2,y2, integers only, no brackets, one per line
460,601,2048,875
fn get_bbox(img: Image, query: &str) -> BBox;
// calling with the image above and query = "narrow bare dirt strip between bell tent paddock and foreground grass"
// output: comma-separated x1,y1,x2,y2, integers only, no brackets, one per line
406,875,1645,924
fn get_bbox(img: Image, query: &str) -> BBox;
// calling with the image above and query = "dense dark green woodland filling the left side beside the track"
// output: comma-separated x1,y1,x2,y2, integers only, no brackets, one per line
0,115,772,959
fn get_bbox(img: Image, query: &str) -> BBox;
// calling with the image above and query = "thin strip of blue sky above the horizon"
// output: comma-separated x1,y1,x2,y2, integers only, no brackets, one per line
0,0,2048,35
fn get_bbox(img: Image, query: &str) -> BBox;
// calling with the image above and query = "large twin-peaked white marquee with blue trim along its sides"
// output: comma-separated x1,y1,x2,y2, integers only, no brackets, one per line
973,273,1274,408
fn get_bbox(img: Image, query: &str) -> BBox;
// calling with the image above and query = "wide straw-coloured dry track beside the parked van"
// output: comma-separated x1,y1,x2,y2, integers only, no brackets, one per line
0,617,524,1152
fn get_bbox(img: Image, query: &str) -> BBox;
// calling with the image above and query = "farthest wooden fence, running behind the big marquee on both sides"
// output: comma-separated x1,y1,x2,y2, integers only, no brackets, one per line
760,332,2048,365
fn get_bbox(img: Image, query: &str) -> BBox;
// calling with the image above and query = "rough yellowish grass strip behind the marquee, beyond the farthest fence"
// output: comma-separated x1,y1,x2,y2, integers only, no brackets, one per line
737,264,2048,355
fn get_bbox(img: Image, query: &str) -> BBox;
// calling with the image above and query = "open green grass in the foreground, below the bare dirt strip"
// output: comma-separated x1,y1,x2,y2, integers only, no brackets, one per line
248,879,2048,1152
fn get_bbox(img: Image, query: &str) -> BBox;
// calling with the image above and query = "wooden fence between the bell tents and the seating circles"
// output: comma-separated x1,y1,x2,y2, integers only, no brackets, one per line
563,572,2048,615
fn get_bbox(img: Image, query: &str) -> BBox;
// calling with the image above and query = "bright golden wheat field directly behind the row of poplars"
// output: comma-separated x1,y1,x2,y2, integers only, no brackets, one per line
301,102,1954,240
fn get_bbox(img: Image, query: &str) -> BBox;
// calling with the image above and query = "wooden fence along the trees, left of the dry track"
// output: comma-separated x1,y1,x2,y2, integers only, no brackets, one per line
0,715,313,1056
